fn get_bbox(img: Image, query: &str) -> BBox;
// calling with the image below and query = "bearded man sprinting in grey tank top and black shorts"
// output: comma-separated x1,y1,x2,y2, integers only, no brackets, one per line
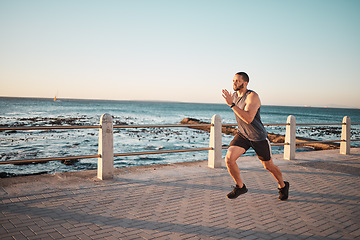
222,72,290,200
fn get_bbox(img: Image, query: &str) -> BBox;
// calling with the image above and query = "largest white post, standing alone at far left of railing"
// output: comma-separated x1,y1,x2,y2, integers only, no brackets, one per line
97,113,114,180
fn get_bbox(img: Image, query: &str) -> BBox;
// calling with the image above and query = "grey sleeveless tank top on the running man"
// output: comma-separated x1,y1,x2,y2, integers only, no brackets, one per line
232,90,267,141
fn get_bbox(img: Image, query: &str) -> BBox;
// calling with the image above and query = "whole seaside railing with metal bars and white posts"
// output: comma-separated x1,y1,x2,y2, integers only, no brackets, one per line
0,114,360,179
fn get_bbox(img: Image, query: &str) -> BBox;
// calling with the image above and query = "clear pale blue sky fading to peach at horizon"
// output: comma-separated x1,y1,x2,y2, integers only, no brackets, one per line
0,0,360,107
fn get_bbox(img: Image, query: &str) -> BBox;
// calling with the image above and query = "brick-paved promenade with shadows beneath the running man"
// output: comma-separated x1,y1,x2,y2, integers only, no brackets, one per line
0,148,360,239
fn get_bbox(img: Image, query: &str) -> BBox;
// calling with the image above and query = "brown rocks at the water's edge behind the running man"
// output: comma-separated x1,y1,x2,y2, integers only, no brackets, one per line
180,118,340,150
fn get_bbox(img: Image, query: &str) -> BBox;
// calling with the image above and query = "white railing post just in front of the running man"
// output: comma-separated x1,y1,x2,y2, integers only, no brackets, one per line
208,114,222,168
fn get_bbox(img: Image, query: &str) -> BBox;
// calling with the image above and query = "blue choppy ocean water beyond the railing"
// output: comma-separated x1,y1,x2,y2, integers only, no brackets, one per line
0,97,360,177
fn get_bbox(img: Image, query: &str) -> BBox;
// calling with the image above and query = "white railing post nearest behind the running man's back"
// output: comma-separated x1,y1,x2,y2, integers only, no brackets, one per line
284,115,296,160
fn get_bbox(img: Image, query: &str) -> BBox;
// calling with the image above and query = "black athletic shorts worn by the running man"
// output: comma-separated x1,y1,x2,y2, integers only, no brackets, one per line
230,133,272,161
